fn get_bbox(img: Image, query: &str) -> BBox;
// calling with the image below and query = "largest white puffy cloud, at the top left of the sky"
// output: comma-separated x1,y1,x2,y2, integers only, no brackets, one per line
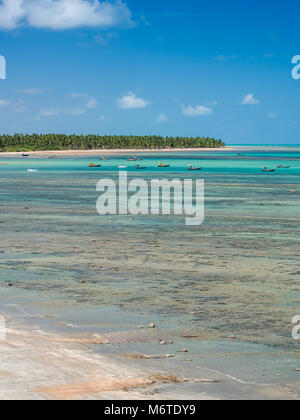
0,0,131,30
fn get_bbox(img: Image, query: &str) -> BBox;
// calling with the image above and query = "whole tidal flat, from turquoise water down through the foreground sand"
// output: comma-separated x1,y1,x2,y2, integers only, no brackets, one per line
0,147,300,399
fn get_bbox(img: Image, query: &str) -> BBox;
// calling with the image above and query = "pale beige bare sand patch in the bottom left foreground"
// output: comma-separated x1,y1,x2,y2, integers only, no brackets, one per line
0,318,192,400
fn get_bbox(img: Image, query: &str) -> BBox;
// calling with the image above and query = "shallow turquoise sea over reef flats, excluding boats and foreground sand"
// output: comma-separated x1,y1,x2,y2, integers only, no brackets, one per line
0,147,300,395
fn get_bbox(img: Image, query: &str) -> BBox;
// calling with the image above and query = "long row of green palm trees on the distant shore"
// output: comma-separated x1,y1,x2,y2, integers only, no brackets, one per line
0,134,225,152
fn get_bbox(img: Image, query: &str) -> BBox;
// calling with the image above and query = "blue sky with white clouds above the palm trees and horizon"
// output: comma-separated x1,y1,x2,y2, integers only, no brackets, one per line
0,0,300,144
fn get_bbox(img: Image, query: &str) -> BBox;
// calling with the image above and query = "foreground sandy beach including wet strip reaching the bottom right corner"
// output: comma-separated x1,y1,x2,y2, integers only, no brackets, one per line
0,312,295,401
